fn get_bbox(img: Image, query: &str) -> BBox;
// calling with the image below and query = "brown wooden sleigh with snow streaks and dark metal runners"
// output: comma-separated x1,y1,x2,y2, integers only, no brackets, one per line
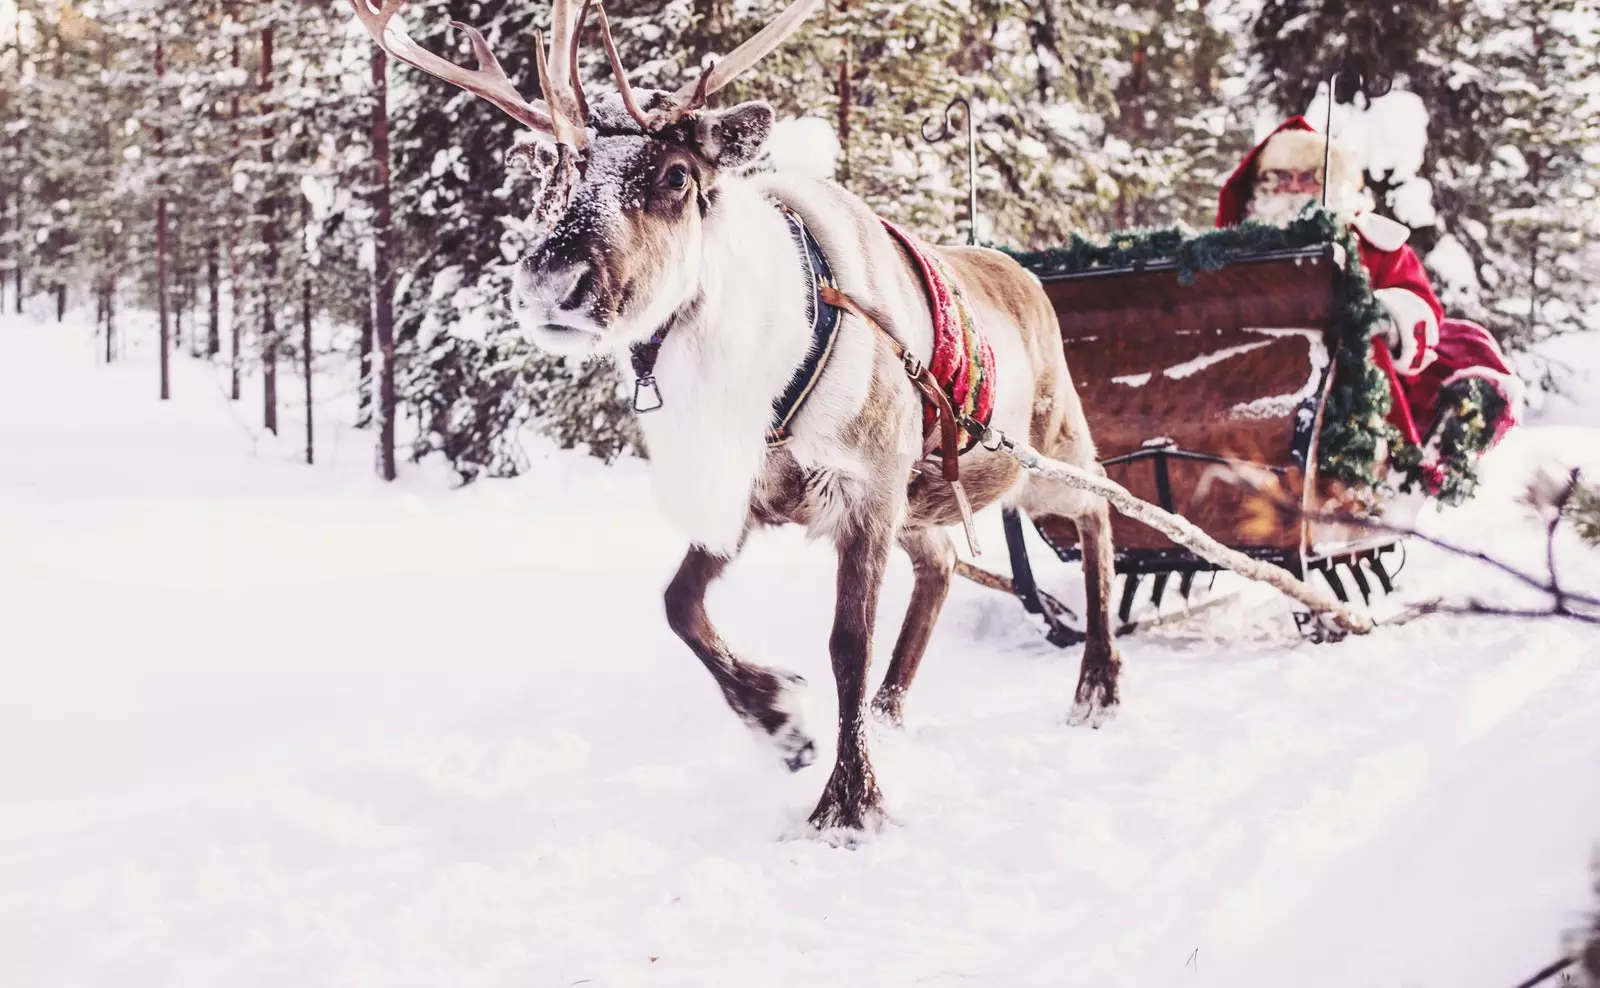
1005,245,1398,644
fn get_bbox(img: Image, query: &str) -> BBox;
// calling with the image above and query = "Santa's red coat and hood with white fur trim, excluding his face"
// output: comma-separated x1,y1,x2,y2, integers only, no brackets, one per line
1216,117,1522,443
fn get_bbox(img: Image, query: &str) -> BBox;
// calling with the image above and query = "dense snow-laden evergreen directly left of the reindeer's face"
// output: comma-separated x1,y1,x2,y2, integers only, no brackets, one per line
390,0,637,478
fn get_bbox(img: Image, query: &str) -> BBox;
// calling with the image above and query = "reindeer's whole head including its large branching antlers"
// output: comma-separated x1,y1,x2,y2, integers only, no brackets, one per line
352,0,821,353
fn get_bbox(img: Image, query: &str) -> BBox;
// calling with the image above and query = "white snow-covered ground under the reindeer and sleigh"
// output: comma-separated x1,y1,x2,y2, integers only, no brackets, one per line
9,313,1600,988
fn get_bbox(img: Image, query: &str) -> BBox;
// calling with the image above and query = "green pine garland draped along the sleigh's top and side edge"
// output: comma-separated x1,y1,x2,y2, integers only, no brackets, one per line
1000,208,1507,504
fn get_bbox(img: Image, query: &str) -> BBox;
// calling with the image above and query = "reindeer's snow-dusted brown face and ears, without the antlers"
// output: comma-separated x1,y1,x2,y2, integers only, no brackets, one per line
512,93,773,355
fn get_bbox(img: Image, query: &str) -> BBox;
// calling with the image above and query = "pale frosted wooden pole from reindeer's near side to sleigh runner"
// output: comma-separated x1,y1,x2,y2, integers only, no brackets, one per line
1000,436,1373,635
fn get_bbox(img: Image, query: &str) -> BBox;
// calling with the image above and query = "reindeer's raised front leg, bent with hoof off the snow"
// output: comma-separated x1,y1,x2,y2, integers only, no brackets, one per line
666,547,816,772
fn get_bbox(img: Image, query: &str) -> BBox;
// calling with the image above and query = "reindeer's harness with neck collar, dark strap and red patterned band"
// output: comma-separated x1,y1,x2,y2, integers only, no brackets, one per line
630,203,995,555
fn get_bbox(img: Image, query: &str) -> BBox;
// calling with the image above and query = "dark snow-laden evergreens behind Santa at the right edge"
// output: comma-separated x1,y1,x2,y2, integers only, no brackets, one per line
1253,0,1600,342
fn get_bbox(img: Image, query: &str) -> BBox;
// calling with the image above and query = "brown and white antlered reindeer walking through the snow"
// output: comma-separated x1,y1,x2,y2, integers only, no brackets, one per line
352,0,1120,843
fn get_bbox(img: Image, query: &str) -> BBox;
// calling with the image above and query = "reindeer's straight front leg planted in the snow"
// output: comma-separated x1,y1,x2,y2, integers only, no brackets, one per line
811,512,894,831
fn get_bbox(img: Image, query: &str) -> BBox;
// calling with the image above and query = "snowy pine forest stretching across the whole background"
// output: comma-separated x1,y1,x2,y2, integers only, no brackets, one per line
0,0,1600,480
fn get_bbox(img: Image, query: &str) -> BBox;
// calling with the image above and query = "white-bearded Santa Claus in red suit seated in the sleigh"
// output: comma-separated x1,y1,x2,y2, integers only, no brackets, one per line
1216,117,1522,457
